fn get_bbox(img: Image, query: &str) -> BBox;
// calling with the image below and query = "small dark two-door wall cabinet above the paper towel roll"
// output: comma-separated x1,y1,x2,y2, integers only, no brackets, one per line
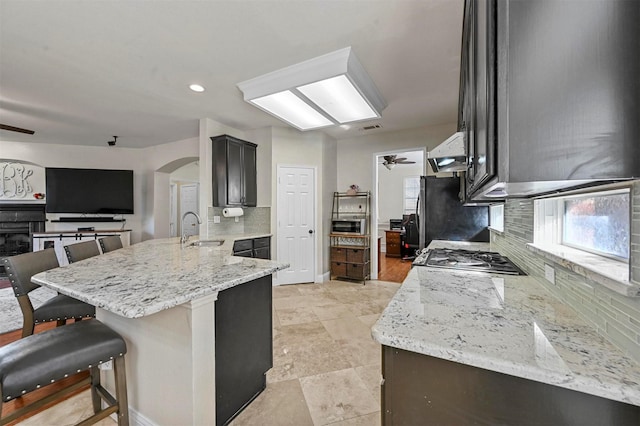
211,135,258,207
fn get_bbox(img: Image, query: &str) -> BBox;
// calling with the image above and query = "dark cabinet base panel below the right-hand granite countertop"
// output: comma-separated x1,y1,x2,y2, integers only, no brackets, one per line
381,346,640,426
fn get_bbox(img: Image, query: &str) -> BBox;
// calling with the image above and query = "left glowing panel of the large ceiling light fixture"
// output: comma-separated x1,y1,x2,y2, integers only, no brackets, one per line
251,90,333,130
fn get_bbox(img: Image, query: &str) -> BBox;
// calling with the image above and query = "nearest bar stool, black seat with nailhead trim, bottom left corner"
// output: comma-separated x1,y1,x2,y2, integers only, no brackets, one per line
0,320,129,426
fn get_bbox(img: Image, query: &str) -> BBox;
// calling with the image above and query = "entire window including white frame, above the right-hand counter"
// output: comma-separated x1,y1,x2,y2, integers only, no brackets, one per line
534,189,630,262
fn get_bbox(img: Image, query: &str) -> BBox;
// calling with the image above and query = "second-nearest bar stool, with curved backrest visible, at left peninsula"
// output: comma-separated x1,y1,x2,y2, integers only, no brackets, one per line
2,248,96,337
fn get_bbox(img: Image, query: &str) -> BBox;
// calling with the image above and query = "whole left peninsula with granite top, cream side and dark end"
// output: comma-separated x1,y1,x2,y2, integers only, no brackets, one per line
33,235,288,425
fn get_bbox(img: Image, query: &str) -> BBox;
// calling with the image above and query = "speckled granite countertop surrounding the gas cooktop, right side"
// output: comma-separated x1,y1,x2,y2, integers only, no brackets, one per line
372,241,640,406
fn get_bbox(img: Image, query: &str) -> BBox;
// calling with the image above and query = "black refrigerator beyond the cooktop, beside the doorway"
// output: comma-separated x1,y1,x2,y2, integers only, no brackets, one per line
416,176,489,249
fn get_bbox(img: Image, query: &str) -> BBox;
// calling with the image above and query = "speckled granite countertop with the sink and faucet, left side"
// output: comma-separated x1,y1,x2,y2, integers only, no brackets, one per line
32,234,289,318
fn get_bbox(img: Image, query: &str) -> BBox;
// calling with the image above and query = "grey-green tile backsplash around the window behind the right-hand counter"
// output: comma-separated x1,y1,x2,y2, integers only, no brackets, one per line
491,182,640,362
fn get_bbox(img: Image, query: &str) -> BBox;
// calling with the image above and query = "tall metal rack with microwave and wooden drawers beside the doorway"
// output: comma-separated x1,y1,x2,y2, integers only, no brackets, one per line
329,190,371,284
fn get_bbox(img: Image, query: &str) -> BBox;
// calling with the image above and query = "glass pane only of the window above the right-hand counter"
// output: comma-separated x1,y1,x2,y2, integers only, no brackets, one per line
561,192,629,261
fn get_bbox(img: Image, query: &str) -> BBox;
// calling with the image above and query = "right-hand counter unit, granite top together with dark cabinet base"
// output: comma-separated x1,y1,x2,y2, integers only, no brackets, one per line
372,241,640,425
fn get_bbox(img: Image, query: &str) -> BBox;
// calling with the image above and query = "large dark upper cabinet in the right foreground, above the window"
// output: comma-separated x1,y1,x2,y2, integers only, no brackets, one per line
460,0,640,200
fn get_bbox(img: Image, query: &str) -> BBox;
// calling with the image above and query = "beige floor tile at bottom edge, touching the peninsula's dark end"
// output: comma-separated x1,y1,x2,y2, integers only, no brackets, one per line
230,380,313,426
